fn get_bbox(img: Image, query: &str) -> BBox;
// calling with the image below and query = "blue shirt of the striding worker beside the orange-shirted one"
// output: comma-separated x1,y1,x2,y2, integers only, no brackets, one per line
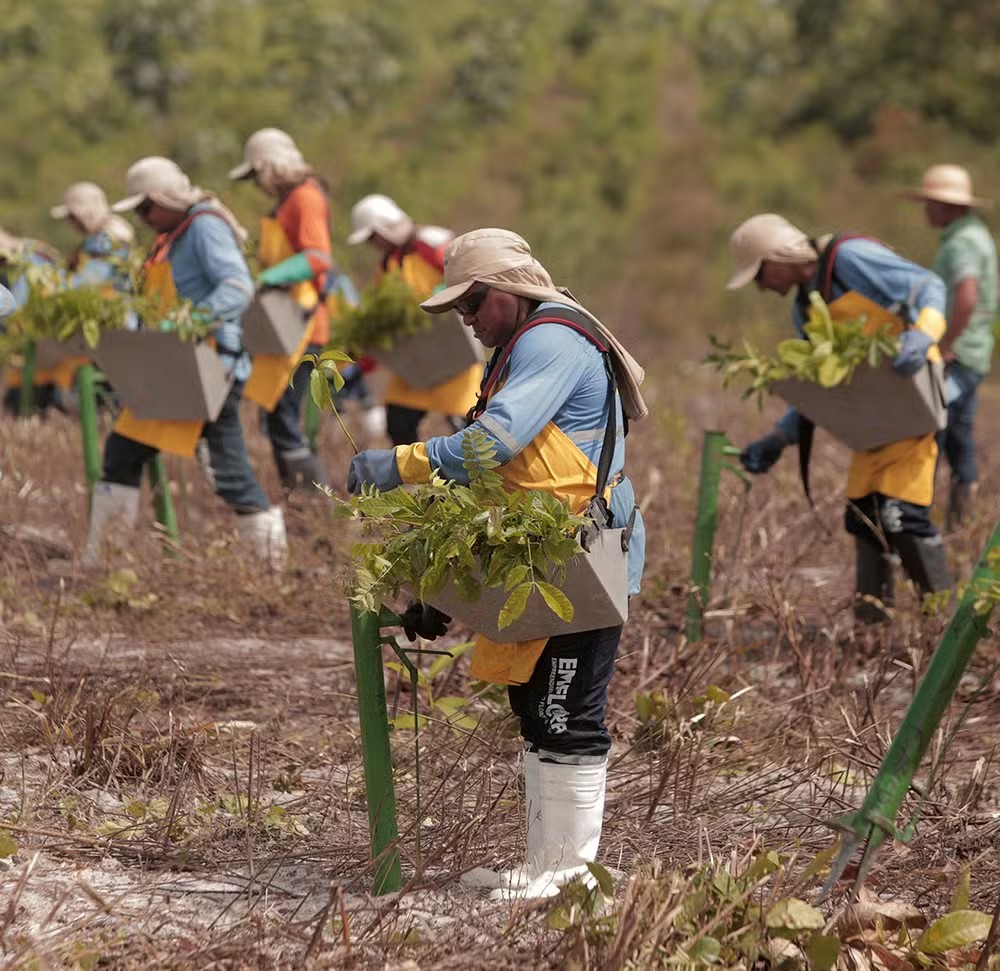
167,203,254,381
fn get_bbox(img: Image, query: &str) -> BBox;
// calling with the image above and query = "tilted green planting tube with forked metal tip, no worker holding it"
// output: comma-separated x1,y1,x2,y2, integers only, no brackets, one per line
824,523,1000,893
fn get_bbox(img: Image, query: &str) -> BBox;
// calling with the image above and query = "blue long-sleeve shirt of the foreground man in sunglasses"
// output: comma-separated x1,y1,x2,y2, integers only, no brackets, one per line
418,303,646,594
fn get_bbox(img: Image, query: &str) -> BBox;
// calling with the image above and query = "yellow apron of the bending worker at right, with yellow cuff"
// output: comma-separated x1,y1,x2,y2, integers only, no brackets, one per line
830,291,941,506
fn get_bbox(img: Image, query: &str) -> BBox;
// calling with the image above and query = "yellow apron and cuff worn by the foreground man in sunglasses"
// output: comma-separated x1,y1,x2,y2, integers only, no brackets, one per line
396,360,611,684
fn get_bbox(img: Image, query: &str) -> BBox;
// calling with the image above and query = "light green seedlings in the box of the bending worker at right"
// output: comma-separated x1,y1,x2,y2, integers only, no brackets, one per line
705,291,899,401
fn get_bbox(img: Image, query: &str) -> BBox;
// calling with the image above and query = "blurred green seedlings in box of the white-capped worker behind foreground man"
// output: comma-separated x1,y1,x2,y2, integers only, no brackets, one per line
330,273,434,353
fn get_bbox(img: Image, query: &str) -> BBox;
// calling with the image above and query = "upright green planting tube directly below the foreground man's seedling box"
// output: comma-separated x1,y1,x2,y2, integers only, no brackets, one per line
351,606,403,895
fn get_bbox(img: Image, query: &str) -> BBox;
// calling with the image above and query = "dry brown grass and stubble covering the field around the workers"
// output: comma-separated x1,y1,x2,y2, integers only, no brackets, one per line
0,365,1000,969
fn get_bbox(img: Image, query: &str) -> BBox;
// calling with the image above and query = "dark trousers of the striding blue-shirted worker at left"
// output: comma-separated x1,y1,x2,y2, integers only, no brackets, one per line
101,381,271,515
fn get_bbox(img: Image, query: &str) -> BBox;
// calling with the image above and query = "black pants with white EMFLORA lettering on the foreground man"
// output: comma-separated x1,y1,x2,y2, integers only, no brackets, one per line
507,625,622,763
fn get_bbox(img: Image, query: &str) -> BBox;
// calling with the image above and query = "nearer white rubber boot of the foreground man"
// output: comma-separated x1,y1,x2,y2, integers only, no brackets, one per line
490,759,608,900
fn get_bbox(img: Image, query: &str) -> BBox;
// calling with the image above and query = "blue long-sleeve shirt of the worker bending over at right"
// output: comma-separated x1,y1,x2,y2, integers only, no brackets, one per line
775,239,947,444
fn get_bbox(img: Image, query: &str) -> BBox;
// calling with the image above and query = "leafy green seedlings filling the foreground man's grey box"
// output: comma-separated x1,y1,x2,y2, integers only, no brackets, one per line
341,429,588,629
